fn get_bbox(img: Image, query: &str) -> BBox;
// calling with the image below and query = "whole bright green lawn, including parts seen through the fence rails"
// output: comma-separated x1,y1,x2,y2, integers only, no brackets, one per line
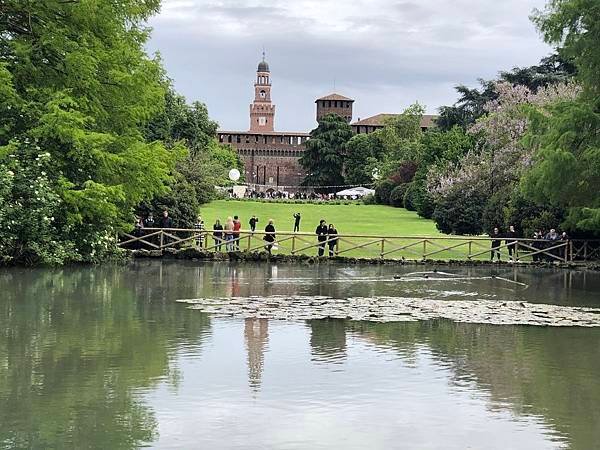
182,200,536,260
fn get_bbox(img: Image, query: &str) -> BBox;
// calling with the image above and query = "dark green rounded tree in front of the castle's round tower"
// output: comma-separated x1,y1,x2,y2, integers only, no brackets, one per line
300,114,353,191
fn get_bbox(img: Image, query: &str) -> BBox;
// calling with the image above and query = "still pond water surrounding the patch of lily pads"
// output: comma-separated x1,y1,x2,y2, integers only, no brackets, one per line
0,261,600,450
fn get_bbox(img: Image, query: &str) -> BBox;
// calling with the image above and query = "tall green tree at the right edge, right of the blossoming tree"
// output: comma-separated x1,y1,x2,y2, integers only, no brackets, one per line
522,0,600,233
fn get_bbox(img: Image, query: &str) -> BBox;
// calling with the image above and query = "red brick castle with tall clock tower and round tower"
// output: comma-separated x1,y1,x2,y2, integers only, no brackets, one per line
218,55,436,192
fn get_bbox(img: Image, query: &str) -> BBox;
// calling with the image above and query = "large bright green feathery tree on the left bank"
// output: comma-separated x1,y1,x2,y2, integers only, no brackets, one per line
0,0,177,262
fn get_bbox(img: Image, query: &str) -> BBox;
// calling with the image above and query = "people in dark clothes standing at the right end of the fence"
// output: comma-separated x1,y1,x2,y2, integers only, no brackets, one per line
490,225,569,261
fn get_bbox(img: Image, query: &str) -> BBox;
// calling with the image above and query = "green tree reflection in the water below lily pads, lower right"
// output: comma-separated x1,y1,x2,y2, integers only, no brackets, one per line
348,320,600,449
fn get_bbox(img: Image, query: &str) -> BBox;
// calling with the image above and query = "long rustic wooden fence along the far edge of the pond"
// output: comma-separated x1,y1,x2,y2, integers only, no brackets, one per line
117,228,600,262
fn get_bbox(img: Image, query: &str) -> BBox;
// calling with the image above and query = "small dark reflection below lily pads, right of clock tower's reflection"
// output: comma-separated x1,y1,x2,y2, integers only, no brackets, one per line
306,319,346,362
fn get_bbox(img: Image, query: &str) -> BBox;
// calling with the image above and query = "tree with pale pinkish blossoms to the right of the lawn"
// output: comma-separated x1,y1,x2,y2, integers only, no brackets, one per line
427,82,580,232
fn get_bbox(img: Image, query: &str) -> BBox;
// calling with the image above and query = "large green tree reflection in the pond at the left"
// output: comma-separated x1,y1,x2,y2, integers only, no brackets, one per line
0,267,210,449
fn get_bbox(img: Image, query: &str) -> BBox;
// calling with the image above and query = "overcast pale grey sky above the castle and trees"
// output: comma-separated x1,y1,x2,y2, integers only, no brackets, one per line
149,0,551,131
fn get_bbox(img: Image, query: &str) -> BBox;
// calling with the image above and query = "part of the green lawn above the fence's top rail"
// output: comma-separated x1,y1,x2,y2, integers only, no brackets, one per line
200,200,442,236
